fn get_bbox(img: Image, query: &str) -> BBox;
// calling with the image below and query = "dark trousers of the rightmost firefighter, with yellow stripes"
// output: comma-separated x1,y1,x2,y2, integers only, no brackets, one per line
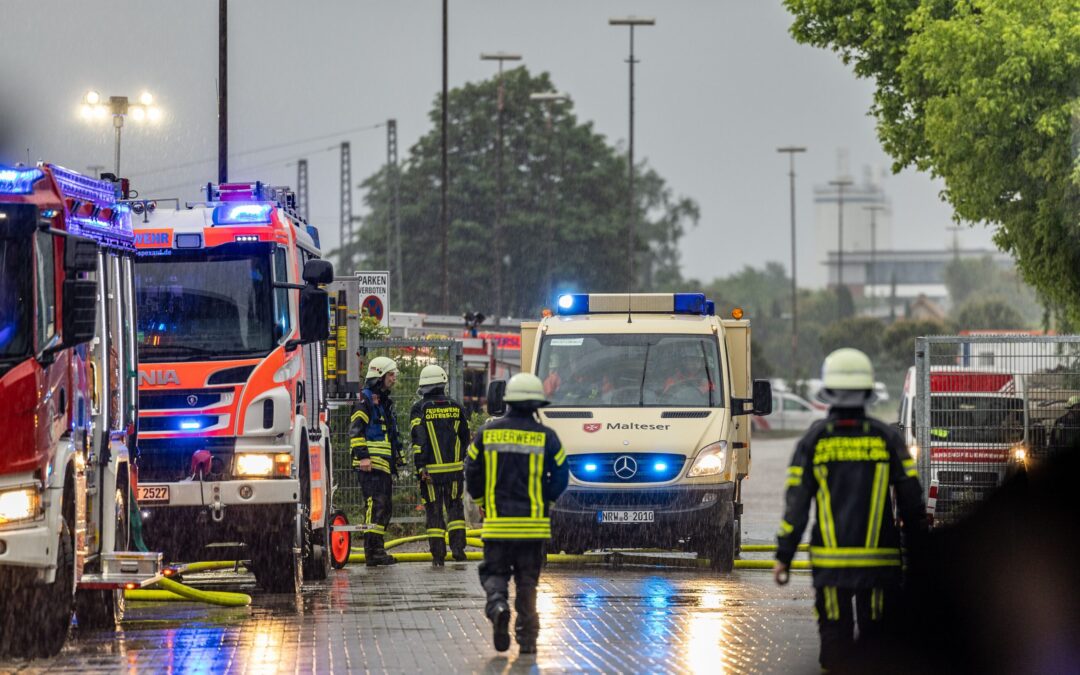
814,586,895,671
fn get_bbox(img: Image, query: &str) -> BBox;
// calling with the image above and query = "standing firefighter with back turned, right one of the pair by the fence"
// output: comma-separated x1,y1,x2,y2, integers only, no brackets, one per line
409,365,469,567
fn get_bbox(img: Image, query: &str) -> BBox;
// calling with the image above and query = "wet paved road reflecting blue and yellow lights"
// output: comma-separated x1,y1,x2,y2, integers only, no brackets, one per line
0,438,818,673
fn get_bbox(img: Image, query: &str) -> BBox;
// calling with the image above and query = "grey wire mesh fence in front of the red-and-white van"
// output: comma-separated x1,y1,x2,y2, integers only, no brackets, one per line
915,335,1080,525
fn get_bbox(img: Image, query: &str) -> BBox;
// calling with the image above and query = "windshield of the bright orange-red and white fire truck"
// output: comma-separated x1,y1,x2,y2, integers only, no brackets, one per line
135,244,280,362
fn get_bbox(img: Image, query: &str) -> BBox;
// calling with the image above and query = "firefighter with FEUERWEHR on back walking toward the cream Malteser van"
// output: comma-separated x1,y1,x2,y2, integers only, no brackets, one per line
465,373,570,653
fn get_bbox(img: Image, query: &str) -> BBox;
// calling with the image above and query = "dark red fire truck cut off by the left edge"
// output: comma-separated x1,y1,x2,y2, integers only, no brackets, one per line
0,164,161,657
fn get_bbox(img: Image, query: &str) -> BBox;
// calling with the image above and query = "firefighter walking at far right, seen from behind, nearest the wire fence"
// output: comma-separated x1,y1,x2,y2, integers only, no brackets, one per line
773,349,924,670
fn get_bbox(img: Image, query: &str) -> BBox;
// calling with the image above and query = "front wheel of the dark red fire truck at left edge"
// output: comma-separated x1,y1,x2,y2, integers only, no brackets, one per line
0,517,75,659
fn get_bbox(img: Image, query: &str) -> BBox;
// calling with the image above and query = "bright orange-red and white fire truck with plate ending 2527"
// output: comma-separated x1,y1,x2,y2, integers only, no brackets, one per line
133,183,334,592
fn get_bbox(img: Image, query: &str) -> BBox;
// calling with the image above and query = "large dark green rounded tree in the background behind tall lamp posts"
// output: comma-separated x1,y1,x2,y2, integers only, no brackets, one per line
343,67,699,316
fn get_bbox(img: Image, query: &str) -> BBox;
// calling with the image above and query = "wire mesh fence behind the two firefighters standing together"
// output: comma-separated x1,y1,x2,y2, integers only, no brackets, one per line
329,339,462,529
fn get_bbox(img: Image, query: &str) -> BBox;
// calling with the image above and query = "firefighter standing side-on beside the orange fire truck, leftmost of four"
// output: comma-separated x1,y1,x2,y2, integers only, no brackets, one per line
349,356,401,567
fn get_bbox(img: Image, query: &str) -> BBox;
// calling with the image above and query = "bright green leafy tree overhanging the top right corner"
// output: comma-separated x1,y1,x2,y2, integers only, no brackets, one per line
784,0,1080,319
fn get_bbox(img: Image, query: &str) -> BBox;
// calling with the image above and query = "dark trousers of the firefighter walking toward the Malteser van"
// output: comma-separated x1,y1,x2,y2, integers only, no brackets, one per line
480,540,543,645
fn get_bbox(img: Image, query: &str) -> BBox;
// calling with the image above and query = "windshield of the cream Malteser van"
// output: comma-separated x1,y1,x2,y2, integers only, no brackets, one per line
537,334,724,407
